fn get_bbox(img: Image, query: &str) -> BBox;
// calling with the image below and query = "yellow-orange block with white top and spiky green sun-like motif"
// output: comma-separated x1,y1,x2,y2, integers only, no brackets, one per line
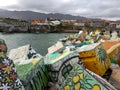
79,43,111,76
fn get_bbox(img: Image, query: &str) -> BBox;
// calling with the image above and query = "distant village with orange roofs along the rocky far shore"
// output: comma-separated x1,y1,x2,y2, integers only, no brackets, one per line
0,18,120,34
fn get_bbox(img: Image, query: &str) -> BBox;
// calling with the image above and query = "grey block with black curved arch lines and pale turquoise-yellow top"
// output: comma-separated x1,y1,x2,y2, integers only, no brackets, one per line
45,51,80,84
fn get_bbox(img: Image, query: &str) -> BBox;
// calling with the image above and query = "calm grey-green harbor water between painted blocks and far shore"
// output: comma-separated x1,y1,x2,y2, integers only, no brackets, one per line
0,33,68,56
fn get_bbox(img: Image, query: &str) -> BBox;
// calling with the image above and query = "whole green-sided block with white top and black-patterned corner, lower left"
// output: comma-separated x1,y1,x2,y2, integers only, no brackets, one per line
9,45,49,90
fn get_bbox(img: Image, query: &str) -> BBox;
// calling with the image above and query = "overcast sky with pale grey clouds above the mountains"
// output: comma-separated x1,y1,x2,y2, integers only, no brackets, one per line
0,0,120,20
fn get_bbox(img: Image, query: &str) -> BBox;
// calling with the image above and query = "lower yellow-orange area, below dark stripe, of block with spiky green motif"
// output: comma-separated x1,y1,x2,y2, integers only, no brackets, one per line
82,57,111,76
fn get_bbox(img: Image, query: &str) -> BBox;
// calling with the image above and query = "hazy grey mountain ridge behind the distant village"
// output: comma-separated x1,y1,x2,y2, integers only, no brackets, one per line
0,9,87,20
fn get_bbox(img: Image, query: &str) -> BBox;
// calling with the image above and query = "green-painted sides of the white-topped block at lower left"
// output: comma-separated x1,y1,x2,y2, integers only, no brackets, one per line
16,58,49,90
